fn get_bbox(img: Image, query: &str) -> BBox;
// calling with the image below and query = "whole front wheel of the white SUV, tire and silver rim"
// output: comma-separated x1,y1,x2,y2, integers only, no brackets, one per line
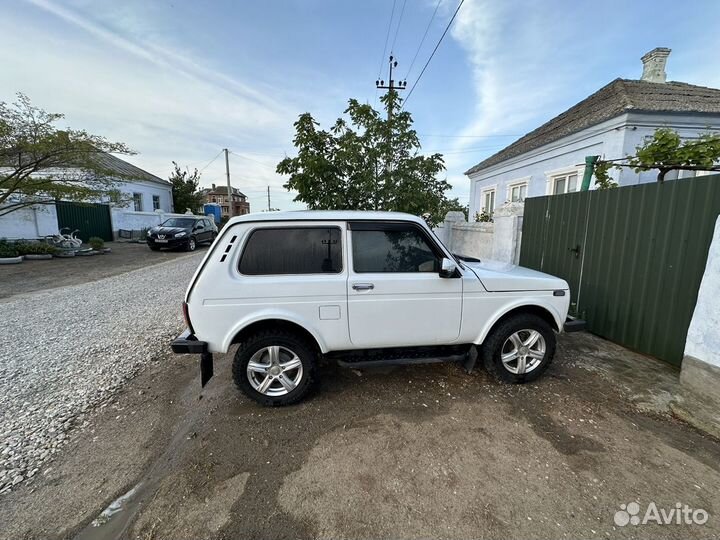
481,313,556,384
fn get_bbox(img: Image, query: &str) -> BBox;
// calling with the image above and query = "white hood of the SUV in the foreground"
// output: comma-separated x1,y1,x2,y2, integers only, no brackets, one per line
463,261,568,292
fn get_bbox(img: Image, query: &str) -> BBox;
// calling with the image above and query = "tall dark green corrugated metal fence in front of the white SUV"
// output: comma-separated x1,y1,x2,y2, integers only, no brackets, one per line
520,175,720,365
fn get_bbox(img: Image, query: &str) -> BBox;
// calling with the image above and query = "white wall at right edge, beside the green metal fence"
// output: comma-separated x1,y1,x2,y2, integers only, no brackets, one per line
685,217,720,367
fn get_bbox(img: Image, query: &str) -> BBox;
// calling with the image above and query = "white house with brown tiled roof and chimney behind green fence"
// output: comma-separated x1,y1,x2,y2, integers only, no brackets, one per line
465,48,720,219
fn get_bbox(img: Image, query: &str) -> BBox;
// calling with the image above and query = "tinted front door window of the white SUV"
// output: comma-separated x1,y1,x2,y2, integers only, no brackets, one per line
352,226,440,273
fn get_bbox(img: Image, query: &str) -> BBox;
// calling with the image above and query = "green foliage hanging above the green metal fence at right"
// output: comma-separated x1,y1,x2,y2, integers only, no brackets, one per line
594,128,720,187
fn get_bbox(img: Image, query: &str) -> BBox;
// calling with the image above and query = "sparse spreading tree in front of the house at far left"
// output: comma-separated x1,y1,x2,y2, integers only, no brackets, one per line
0,93,133,216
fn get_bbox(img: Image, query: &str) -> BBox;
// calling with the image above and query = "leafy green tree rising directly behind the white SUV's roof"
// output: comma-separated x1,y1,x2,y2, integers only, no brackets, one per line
277,91,460,224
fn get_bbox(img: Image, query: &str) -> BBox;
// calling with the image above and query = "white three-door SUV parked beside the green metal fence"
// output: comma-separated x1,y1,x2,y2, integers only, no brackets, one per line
172,211,583,405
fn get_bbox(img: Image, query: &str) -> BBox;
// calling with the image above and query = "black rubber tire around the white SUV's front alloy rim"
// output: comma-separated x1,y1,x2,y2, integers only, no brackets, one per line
481,313,556,384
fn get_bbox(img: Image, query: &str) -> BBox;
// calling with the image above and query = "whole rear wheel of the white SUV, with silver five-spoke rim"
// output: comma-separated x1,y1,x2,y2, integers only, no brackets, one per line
233,330,317,407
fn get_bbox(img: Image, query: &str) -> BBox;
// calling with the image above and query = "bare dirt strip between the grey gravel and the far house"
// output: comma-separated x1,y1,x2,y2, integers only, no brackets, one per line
0,242,206,303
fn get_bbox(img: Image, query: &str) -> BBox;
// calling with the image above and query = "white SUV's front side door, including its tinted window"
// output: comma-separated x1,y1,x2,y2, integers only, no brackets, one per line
347,222,462,348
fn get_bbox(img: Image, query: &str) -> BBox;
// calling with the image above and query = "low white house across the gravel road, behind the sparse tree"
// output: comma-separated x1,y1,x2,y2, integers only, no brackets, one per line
0,154,174,240
